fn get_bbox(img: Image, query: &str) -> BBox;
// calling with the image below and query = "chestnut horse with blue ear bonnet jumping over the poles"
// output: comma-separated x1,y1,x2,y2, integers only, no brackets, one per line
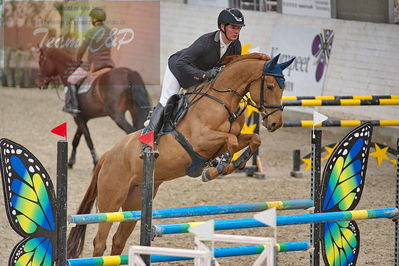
67,53,293,258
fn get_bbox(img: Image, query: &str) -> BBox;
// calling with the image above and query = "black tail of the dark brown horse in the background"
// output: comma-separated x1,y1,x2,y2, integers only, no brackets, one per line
129,71,151,129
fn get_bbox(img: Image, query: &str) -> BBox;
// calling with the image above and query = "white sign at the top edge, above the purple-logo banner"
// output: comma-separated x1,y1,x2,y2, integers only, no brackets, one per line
282,0,331,18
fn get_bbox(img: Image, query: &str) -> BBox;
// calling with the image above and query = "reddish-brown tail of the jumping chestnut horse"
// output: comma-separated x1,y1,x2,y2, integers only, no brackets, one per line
67,153,107,259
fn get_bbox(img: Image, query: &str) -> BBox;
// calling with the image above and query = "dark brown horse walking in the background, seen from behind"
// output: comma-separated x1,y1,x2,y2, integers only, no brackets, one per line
39,48,151,168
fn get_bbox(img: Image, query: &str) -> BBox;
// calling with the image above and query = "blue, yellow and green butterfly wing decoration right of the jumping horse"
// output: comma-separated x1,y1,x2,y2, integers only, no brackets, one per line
321,123,373,266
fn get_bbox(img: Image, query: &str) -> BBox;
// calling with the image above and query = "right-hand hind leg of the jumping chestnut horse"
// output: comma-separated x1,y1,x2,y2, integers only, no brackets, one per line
111,183,160,255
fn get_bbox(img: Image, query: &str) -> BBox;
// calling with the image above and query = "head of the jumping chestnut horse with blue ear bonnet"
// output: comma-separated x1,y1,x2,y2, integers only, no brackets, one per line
249,55,295,132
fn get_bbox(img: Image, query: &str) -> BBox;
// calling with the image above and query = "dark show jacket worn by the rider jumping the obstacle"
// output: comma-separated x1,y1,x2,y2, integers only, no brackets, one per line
168,30,241,89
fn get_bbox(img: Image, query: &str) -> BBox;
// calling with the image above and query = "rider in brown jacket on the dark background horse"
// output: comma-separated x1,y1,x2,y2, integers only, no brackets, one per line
63,7,114,114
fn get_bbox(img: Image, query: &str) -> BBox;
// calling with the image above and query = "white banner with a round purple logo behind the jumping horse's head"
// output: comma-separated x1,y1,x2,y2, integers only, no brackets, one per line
269,24,334,96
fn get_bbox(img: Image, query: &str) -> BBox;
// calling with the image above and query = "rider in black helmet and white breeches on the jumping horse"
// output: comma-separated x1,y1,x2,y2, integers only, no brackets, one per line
142,8,245,135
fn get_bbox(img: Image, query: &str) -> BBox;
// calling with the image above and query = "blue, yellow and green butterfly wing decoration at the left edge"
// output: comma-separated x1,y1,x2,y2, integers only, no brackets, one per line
0,139,56,266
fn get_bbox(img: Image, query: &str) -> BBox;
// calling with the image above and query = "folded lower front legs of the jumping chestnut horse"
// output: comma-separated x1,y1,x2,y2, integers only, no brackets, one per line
202,134,261,182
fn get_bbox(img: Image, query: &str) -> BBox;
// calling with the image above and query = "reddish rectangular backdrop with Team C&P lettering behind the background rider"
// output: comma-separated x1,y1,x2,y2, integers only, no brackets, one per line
2,0,160,87
